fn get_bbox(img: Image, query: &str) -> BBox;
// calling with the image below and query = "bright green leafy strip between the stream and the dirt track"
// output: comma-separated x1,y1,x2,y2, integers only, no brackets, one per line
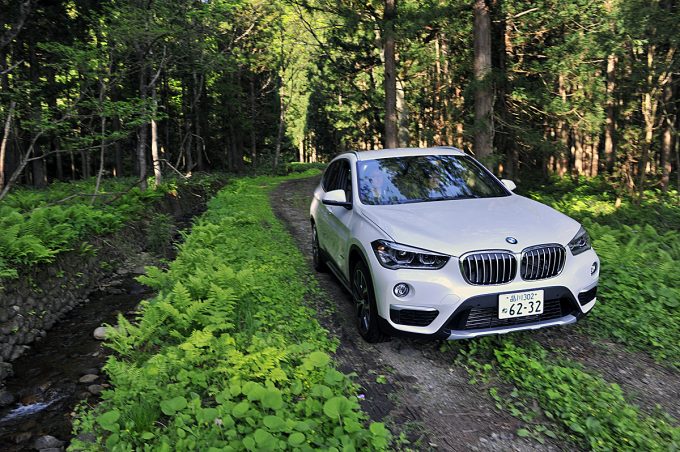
71,173,389,450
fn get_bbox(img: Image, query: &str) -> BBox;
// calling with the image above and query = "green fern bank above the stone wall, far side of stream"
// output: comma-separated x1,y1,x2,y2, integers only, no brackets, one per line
0,176,223,279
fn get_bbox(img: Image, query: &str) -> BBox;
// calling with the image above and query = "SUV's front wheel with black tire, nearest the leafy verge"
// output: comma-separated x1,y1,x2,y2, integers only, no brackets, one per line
352,261,388,344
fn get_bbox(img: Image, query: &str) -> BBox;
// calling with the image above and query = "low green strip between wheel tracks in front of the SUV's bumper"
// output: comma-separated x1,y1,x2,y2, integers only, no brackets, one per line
461,336,680,450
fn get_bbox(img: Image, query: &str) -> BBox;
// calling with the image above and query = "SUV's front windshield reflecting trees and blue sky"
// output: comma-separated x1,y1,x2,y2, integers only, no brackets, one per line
357,155,509,205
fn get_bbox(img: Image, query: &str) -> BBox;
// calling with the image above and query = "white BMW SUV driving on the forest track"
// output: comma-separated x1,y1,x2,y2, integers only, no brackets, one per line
310,148,600,342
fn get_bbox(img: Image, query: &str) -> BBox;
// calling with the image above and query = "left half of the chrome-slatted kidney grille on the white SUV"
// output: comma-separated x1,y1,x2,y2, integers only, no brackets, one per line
461,251,517,286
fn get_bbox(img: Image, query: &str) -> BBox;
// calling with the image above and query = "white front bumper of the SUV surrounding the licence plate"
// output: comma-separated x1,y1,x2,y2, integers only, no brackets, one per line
371,250,599,339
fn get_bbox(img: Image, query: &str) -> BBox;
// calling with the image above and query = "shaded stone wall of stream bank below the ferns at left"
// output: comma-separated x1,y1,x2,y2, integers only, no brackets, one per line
0,185,215,388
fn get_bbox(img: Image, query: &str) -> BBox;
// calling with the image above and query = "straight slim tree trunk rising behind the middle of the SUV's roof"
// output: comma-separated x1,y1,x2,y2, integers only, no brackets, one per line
383,0,399,148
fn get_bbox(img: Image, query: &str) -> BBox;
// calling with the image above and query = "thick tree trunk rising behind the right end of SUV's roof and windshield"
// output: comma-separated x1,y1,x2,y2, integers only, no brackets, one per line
473,0,493,164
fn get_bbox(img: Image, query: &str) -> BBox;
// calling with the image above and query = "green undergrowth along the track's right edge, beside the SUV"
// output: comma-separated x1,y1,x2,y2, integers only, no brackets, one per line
530,179,680,369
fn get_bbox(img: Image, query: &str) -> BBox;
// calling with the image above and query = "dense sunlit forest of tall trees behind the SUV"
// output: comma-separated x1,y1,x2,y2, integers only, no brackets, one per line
0,0,680,198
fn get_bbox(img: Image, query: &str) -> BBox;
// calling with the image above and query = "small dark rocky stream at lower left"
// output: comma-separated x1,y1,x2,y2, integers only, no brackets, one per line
0,275,152,452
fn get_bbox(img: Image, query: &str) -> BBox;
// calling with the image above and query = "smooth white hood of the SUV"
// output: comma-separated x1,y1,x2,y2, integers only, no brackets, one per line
362,195,580,256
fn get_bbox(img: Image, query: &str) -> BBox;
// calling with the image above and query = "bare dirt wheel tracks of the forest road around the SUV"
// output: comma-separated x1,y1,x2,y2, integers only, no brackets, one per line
272,177,680,451
